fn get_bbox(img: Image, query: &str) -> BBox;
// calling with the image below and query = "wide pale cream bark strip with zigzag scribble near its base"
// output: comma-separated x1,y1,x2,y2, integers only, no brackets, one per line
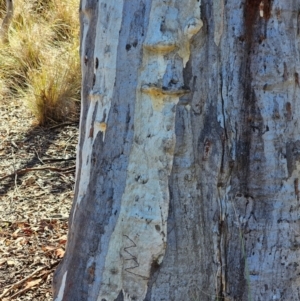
98,0,202,301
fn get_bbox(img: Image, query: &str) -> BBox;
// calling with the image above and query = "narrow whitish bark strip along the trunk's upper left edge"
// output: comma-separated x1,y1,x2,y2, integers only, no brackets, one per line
73,0,123,217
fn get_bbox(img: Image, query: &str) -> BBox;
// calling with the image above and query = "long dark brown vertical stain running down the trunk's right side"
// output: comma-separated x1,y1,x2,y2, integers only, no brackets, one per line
229,0,273,300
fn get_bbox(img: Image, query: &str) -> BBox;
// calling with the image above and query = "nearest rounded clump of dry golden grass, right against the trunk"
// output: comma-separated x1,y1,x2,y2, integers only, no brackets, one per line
24,47,80,124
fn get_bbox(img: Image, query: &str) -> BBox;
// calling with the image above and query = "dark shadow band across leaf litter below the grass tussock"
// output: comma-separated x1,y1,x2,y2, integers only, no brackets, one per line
0,122,78,196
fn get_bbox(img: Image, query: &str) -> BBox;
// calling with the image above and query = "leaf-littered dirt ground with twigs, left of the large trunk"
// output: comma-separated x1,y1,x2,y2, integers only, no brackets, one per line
0,99,78,301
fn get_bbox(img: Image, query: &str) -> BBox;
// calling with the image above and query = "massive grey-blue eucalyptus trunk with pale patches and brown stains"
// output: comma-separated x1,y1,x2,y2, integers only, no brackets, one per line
54,0,300,301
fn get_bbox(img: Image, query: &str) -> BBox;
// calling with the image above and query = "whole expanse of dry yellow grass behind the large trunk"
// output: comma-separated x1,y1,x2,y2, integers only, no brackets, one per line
0,0,81,125
